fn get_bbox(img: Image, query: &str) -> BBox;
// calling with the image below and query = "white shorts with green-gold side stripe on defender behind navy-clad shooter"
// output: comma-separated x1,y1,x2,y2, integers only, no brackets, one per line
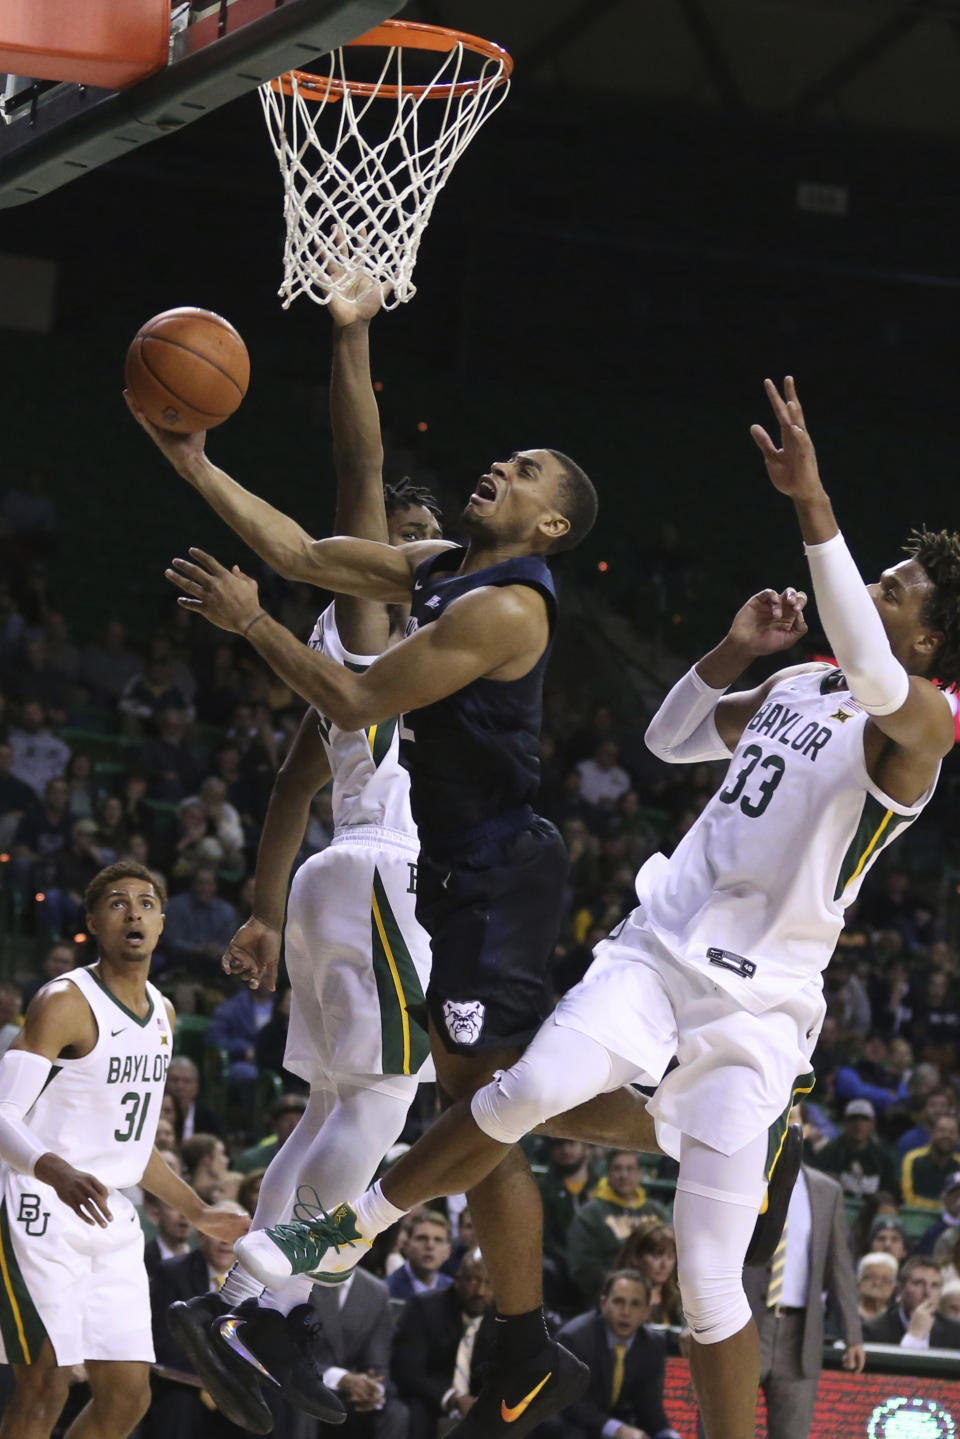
284,826,433,1098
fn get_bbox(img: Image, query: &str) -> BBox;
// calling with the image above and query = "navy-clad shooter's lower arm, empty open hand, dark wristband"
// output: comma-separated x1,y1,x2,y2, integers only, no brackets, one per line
166,550,550,730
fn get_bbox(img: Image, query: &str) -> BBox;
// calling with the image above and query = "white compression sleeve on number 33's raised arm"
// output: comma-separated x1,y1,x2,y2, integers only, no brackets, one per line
803,532,910,715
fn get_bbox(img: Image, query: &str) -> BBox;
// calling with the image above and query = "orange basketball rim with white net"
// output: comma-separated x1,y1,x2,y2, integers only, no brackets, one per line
254,20,514,309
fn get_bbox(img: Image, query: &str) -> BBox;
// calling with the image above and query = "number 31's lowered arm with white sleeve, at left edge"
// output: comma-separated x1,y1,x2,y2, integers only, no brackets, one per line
0,980,112,1229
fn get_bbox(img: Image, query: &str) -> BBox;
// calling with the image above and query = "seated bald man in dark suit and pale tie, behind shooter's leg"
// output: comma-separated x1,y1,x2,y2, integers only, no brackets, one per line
391,1249,497,1439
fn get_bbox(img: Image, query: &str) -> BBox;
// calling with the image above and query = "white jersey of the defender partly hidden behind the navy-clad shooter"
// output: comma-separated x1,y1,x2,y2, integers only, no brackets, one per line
308,603,416,839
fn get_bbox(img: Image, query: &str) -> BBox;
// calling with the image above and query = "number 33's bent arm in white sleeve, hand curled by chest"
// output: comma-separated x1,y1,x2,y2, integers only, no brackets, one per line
645,589,806,764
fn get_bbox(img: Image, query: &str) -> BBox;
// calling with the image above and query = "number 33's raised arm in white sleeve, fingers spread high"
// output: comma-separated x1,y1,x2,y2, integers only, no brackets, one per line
750,376,954,765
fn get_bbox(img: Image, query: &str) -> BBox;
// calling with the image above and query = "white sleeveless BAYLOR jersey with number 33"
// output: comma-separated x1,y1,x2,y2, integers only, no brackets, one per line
633,666,936,1013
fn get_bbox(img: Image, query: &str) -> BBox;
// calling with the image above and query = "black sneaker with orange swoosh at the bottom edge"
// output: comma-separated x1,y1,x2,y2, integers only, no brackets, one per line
450,1340,590,1439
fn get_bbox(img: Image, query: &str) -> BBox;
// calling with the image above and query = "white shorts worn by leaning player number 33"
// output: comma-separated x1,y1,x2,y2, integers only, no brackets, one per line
547,925,825,1158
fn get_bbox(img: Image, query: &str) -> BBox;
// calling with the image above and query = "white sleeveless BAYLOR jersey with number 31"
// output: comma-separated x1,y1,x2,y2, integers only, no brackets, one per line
26,967,173,1189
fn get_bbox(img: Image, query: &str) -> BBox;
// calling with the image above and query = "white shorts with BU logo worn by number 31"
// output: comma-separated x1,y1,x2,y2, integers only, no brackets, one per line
0,1164,154,1366
